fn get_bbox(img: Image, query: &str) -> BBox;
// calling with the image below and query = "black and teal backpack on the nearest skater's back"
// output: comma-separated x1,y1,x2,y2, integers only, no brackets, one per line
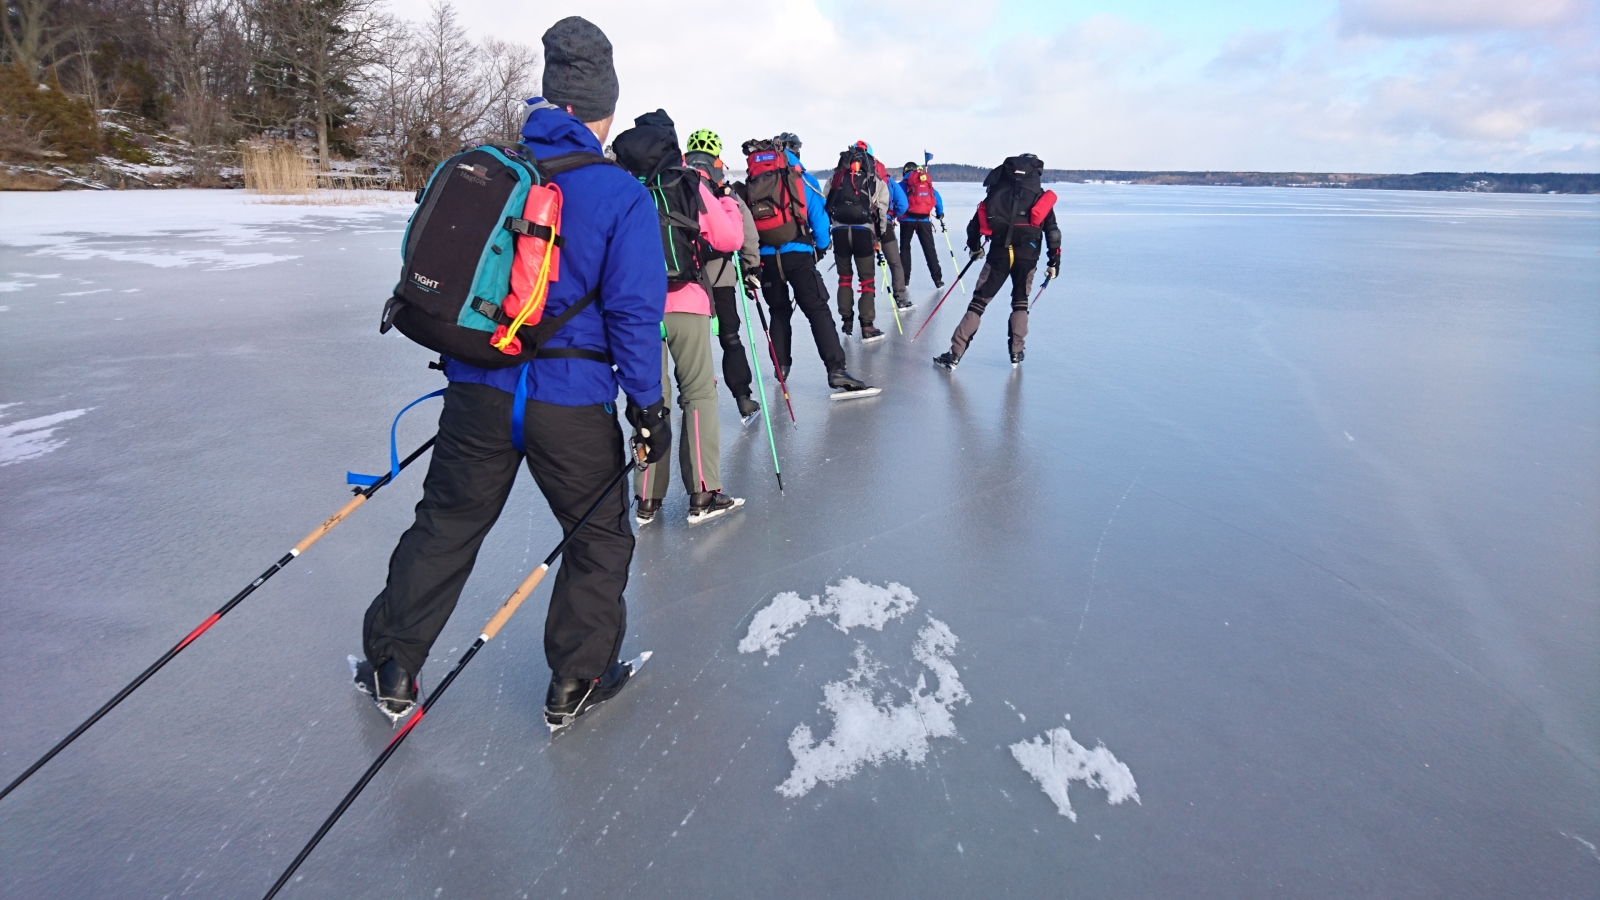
378,146,614,368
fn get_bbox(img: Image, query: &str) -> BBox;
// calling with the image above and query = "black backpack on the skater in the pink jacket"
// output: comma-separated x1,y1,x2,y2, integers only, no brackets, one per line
611,109,710,283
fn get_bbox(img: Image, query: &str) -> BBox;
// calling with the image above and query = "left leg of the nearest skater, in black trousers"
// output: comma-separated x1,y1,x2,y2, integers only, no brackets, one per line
362,383,520,676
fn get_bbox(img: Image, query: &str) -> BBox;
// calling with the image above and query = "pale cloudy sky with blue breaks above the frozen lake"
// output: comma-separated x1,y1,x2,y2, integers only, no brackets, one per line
394,0,1600,173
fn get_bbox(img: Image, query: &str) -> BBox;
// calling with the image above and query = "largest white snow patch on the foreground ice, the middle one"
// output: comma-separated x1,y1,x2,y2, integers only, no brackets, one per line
776,611,971,798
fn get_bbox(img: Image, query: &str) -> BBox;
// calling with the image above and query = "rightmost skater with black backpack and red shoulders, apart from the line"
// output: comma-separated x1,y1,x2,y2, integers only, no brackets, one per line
933,154,1061,372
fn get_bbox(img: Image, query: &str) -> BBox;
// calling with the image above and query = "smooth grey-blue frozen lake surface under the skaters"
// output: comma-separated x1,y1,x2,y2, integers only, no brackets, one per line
0,186,1600,900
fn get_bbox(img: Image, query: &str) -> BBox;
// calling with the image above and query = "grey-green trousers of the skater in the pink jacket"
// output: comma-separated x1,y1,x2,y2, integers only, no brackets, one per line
634,312,722,500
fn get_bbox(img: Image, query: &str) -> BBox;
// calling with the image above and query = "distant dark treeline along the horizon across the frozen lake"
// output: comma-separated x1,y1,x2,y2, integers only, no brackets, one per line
930,163,1600,194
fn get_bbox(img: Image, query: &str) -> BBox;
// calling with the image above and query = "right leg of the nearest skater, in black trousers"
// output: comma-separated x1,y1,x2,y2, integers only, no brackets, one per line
525,400,634,679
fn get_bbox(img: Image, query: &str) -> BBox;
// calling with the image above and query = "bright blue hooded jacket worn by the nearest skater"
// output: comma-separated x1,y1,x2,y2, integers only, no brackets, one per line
445,101,667,407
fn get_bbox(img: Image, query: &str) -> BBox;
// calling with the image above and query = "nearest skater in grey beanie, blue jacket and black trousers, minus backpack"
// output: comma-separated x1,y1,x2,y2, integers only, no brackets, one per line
355,16,672,725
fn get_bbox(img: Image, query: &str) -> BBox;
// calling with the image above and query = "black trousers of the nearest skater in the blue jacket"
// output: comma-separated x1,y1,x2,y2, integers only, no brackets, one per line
363,383,634,679
